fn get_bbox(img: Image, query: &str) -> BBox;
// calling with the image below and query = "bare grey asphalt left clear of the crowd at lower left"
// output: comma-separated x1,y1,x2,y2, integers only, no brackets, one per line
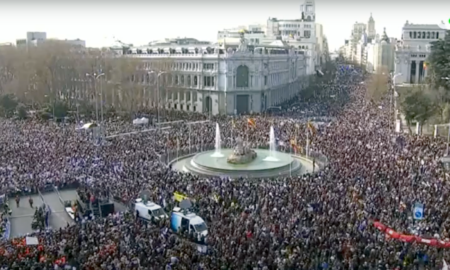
9,190,127,238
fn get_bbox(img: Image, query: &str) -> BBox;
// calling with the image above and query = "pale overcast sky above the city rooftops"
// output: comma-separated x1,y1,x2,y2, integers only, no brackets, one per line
0,0,450,49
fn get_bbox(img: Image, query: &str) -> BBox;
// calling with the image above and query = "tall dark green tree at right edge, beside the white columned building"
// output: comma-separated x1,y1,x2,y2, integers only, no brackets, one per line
426,31,450,92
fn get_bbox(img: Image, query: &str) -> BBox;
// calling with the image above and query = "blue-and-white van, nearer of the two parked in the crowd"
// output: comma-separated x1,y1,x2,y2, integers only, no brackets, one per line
170,207,208,243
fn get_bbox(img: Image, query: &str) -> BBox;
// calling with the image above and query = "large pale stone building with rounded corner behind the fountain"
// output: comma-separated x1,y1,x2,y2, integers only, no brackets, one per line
114,34,306,115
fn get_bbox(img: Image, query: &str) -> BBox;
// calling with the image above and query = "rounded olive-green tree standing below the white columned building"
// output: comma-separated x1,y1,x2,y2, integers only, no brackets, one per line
400,88,435,133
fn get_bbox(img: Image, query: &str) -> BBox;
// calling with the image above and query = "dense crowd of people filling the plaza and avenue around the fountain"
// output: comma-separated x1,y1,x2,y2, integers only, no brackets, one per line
0,62,450,270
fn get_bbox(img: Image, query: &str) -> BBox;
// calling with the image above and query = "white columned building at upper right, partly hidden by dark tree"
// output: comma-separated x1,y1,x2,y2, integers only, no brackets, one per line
395,21,446,84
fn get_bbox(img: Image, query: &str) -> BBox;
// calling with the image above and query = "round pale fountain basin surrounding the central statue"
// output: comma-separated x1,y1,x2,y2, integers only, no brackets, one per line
172,149,312,178
